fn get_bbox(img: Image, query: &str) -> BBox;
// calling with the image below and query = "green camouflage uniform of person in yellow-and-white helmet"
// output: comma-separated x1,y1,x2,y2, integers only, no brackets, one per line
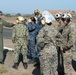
12,24,29,63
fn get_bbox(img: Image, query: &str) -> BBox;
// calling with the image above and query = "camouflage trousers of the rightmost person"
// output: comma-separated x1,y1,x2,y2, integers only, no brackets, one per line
64,51,73,75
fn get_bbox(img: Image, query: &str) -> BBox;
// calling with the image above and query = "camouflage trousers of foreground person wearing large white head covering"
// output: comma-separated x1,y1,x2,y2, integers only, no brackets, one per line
39,53,57,75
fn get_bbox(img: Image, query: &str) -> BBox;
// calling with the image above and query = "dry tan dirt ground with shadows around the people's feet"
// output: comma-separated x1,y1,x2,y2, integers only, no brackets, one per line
0,39,76,75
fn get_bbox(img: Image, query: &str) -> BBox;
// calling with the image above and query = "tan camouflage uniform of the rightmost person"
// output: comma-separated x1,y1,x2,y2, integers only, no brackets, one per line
62,24,76,75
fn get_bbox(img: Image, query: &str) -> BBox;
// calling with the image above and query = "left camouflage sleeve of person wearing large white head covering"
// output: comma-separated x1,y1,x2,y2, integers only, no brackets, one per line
37,29,45,47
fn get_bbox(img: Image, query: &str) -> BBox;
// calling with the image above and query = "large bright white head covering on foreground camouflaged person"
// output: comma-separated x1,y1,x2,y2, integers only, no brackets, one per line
42,11,55,23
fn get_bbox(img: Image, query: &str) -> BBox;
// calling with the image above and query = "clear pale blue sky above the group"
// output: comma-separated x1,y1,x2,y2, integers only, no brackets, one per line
0,0,76,14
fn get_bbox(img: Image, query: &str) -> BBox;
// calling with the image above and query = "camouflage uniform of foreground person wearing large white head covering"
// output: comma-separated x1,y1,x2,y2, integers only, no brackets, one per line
37,25,60,75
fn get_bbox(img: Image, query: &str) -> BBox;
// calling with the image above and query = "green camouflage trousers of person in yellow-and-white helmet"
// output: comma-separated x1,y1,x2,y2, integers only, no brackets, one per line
14,44,28,63
